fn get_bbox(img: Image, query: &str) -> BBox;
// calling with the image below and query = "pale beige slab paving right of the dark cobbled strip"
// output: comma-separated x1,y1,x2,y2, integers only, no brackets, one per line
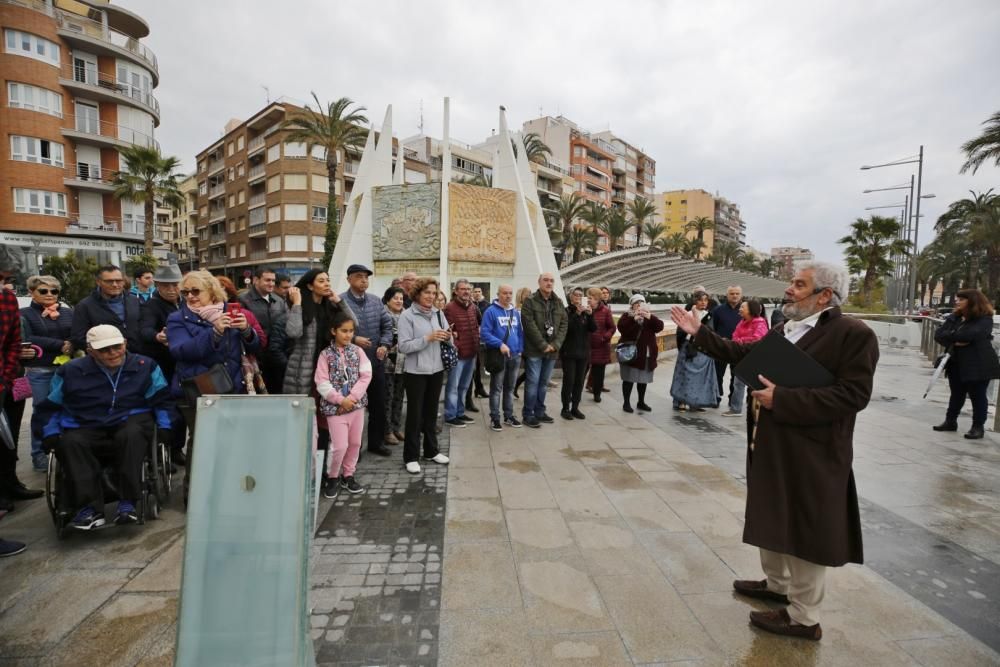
438,350,1000,665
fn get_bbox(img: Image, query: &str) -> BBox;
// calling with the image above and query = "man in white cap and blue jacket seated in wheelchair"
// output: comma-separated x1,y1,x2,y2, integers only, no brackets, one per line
39,324,170,530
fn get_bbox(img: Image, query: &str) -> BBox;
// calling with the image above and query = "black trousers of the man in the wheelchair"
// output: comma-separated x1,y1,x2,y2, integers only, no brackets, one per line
56,413,153,512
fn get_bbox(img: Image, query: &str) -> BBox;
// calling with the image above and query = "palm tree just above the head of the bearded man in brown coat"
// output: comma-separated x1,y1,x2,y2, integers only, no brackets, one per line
837,215,910,306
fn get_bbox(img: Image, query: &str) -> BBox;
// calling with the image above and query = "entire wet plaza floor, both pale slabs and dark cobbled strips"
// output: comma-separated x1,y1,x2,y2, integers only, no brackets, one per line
0,348,1000,667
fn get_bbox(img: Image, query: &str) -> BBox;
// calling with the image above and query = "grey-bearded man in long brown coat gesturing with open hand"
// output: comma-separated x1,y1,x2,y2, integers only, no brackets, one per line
671,262,879,639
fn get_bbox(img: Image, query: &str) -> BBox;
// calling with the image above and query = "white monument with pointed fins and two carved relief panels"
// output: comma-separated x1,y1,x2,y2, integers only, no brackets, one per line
328,98,563,296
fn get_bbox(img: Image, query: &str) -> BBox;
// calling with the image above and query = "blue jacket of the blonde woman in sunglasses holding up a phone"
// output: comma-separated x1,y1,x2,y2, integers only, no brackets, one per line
167,304,260,397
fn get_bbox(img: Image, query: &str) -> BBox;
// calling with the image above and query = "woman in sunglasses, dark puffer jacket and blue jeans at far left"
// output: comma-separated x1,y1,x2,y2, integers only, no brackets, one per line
21,276,73,472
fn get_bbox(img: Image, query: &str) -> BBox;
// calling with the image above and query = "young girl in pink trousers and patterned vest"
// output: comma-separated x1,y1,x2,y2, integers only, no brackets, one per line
314,312,372,498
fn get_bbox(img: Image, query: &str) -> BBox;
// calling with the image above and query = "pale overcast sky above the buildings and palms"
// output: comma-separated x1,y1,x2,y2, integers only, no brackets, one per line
131,0,1000,260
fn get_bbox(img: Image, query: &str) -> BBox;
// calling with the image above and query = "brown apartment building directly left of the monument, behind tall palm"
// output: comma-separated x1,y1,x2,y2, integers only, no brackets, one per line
194,100,427,284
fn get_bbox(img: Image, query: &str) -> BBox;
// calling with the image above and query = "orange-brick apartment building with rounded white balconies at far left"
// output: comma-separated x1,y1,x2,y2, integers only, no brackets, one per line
0,0,165,273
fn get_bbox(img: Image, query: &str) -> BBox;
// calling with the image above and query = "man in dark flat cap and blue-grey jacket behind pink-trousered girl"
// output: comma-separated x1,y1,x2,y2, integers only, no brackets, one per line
340,264,392,456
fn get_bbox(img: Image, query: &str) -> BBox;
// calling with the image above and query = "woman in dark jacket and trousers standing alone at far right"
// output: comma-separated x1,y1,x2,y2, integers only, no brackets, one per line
934,289,1000,440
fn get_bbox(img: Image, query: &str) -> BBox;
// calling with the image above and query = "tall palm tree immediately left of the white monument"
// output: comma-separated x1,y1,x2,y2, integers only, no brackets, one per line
281,92,369,266
